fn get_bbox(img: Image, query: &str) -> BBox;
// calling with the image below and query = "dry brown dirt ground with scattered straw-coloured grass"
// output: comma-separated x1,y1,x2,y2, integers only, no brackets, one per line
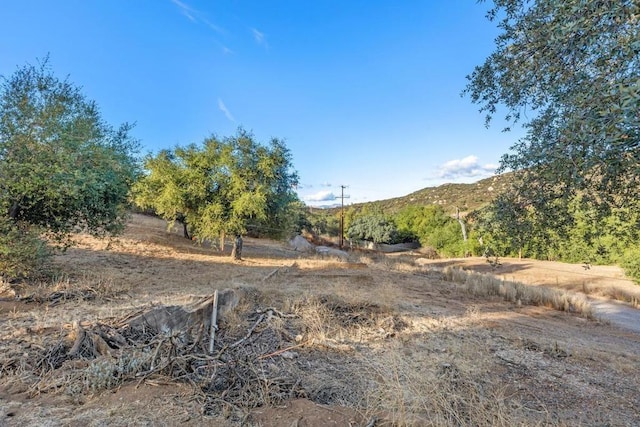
0,215,640,427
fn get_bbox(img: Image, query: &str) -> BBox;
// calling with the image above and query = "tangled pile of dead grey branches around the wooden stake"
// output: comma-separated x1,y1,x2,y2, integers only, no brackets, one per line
15,289,320,423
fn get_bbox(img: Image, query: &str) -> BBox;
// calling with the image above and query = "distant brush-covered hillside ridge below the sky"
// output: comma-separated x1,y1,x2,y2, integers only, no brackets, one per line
327,173,512,214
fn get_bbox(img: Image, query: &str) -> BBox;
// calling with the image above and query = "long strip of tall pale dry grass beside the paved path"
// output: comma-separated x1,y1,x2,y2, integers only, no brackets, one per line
443,267,595,319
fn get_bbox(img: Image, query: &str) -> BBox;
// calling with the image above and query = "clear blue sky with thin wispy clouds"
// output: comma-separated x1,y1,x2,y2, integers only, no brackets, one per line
0,0,519,204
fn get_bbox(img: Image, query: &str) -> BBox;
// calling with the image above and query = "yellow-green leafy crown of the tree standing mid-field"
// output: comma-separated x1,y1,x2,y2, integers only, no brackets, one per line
133,129,298,246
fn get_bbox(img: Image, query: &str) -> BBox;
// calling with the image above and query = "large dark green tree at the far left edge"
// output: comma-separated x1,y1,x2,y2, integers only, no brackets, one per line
0,59,138,278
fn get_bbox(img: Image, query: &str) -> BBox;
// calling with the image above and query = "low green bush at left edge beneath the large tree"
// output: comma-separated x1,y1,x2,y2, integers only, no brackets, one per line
0,217,49,279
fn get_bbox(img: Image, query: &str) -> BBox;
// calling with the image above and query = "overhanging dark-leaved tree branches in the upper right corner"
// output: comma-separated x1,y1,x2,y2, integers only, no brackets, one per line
465,0,640,226
